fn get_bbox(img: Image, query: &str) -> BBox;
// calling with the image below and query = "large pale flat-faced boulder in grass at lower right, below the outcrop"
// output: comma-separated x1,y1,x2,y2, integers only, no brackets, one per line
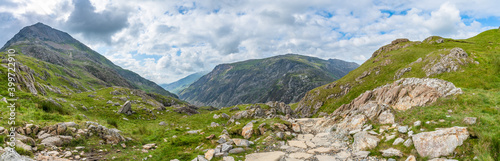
413,127,469,158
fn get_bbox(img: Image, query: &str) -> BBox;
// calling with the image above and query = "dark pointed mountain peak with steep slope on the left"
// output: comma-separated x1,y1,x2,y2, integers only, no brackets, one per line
1,23,177,97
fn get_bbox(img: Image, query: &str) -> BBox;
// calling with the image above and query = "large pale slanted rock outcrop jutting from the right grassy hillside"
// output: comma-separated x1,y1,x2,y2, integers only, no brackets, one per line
332,78,462,130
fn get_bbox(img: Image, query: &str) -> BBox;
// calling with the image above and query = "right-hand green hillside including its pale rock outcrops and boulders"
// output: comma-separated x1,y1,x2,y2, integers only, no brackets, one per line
294,29,500,160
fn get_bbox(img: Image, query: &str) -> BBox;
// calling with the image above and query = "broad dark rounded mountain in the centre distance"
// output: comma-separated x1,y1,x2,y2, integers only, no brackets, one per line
179,54,358,107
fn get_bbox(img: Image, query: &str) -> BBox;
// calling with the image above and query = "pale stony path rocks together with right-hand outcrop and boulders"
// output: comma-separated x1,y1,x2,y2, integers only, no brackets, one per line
188,78,476,161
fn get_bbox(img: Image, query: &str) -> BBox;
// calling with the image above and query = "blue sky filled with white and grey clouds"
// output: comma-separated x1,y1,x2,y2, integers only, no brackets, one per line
0,0,500,83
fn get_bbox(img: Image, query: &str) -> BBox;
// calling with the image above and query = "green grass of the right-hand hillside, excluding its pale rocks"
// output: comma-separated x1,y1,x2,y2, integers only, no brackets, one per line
297,29,500,160
